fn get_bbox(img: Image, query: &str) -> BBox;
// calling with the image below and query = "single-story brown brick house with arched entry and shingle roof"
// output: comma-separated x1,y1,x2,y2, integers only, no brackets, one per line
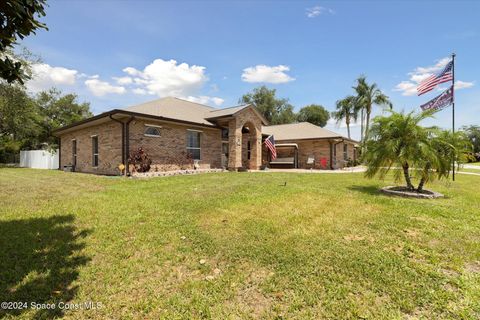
54,98,356,175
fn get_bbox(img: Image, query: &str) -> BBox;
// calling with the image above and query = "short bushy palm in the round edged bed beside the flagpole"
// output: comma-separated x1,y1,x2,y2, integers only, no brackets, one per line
363,111,468,192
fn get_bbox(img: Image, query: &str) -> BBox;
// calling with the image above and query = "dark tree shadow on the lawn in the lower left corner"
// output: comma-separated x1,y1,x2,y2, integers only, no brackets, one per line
0,215,89,319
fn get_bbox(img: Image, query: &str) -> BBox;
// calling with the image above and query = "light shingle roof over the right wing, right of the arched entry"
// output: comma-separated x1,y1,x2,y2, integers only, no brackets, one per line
262,122,351,141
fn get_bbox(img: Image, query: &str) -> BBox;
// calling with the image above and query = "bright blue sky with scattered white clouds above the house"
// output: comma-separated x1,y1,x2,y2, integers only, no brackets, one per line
20,1,480,137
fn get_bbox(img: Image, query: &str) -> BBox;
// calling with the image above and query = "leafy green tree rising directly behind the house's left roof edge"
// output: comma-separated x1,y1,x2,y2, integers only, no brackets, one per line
35,88,93,145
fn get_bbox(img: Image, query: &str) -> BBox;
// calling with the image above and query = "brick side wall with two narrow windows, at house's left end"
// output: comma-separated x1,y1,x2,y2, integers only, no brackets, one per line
60,121,122,174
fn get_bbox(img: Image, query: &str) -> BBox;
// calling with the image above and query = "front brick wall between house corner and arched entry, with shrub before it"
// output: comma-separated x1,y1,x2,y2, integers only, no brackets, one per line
129,119,222,171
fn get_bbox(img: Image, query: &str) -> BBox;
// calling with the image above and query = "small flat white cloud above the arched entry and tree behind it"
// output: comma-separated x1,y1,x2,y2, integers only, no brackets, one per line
242,65,295,83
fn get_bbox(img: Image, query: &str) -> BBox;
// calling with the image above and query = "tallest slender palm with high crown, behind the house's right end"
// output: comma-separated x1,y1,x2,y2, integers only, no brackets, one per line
354,76,392,141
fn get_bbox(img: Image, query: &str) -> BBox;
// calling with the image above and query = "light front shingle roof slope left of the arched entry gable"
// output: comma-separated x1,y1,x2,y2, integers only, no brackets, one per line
125,97,218,125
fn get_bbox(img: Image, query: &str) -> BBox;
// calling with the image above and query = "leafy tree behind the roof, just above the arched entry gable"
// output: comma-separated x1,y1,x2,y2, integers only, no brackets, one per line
239,86,295,124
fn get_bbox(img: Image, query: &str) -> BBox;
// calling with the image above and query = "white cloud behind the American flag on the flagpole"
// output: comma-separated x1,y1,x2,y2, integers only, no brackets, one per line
393,57,474,96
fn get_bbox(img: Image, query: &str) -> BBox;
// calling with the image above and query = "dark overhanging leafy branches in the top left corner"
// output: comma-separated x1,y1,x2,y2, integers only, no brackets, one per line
0,0,47,84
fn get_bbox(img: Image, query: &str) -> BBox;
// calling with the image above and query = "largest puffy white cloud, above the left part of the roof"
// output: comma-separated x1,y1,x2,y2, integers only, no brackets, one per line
123,59,208,97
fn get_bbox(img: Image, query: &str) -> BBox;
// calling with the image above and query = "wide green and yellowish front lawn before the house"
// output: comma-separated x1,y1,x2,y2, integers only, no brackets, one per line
0,168,480,319
